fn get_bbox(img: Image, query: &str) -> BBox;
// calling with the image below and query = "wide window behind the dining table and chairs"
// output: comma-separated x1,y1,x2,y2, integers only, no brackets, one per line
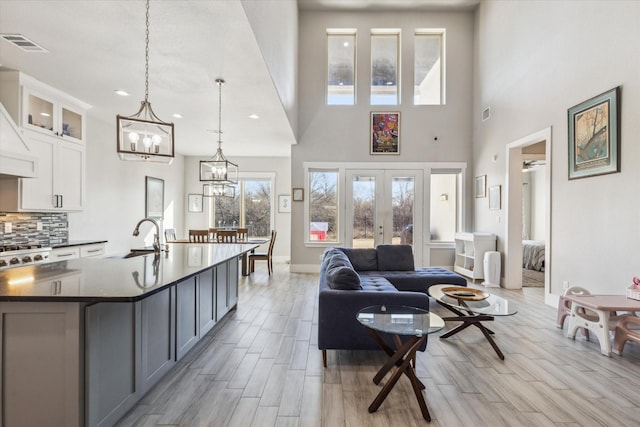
212,178,274,237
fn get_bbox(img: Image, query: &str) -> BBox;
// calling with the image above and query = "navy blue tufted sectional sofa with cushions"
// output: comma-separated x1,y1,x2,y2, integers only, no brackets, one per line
318,245,467,367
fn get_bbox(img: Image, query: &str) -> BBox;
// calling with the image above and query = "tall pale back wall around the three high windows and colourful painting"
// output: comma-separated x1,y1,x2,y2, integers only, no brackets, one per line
291,11,474,265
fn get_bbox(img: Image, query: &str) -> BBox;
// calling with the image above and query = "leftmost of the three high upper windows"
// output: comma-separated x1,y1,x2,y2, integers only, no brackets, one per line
327,29,356,105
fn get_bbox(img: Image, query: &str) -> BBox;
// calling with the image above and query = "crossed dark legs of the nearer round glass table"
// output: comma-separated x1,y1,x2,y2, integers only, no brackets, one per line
367,329,431,421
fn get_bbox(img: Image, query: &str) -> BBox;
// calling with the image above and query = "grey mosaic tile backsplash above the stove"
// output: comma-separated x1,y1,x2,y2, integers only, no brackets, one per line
0,212,69,246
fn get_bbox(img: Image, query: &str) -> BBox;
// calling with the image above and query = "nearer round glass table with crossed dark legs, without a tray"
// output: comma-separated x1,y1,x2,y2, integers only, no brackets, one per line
356,305,444,421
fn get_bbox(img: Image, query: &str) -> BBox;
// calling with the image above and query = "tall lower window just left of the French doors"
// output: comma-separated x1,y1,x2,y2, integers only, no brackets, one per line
307,169,339,243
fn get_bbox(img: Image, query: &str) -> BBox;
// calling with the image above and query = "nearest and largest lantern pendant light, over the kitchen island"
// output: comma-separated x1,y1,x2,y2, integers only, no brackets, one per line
117,0,174,163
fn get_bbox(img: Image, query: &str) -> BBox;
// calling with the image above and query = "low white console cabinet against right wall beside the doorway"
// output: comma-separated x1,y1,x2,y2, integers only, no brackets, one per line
453,233,496,281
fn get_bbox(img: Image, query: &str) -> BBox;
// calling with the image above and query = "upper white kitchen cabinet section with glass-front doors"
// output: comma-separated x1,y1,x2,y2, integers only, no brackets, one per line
0,71,91,144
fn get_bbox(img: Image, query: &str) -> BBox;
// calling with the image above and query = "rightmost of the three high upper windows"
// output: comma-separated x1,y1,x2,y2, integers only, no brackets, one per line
413,29,445,105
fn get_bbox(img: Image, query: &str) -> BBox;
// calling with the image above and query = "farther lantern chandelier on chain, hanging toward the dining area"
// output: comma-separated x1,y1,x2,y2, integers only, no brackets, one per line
200,79,238,197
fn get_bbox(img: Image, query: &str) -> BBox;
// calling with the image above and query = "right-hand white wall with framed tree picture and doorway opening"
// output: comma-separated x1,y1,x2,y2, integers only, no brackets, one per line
473,0,640,294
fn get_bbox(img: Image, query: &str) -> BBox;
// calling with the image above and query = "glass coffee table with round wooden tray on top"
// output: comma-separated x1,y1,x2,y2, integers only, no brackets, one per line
429,285,518,360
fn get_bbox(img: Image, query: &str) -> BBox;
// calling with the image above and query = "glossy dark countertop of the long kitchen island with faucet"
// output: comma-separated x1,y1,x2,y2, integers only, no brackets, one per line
0,244,258,302
